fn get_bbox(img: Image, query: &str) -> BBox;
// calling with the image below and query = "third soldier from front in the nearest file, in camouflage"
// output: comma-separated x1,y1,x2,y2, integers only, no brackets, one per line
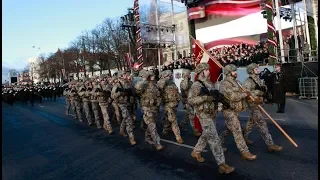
111,71,136,145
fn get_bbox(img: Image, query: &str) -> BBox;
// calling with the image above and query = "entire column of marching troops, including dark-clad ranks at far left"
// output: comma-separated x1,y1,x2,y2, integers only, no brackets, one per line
2,63,282,174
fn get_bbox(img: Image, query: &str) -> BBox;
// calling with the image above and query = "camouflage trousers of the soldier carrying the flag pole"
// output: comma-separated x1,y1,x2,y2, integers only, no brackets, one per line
220,110,249,153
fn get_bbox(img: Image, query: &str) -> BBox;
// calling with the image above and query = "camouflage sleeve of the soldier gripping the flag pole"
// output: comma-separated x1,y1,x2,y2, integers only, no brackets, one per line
220,81,247,102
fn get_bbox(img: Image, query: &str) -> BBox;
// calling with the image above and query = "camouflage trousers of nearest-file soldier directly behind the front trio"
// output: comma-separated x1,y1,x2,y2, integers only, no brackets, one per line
142,107,160,146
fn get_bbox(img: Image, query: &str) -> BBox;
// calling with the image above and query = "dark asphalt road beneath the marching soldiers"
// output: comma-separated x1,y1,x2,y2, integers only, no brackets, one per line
2,98,318,180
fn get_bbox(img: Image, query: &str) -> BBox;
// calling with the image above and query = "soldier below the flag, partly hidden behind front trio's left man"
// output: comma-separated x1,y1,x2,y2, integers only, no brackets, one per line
180,69,201,136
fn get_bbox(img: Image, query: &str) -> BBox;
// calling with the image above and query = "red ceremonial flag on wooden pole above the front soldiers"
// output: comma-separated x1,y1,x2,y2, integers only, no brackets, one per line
192,39,222,132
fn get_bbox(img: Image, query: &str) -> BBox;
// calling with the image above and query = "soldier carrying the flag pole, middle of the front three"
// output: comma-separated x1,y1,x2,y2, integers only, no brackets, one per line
220,64,257,160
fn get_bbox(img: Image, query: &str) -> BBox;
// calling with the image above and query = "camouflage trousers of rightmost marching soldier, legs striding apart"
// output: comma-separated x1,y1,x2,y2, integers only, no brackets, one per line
243,109,274,146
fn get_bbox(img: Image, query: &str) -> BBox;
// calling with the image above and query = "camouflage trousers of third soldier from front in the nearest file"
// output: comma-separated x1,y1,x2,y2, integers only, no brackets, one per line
118,104,134,138
